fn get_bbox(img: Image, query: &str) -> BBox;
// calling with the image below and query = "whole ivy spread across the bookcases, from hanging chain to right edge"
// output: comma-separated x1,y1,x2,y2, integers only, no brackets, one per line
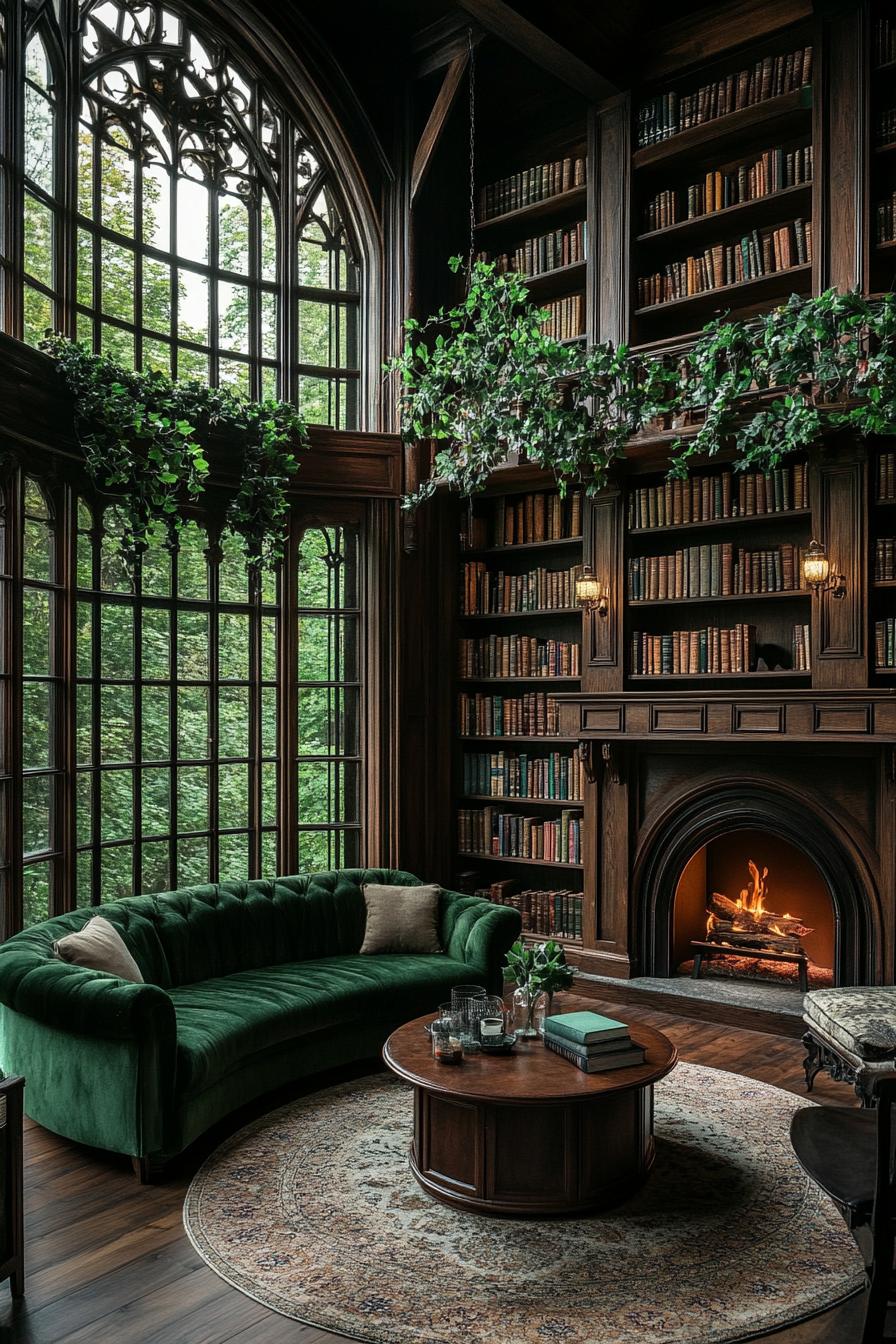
387,257,896,508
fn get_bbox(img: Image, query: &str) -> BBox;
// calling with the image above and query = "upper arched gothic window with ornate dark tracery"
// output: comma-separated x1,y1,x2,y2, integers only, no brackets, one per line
0,0,360,429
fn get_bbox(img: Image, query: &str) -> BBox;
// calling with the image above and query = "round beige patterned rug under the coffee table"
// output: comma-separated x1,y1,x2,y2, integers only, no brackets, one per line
184,1064,862,1344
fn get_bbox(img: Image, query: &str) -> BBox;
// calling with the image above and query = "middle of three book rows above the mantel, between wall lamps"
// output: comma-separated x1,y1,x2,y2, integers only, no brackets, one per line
629,542,802,602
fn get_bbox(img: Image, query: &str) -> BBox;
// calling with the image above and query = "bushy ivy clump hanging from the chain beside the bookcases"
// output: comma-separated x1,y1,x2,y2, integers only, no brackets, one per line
386,257,679,508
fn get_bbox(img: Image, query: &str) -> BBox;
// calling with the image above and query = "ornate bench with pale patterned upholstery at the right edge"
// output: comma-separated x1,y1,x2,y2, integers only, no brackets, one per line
803,985,896,1106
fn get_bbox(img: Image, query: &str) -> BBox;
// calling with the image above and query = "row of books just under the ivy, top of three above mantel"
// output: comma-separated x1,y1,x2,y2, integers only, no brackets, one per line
629,454,811,531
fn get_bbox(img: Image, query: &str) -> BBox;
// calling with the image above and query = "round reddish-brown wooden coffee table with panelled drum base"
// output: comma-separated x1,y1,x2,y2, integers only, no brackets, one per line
383,1015,678,1216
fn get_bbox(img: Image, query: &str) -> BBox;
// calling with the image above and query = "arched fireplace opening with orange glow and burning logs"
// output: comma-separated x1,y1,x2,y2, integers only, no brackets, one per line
672,828,836,989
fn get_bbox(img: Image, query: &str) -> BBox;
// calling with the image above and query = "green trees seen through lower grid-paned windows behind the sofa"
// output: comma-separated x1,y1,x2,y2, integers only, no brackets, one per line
0,473,365,933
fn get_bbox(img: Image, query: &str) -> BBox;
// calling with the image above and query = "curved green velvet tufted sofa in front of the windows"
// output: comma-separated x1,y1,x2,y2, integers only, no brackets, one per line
0,868,520,1177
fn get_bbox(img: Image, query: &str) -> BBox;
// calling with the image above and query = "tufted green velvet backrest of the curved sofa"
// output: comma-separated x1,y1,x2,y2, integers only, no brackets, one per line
16,868,419,989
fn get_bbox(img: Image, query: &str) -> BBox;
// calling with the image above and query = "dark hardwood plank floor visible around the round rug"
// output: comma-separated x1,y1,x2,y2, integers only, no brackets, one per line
0,1000,862,1344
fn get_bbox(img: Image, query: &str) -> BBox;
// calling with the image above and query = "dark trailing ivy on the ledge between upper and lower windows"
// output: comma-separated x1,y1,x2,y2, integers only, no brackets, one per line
40,332,308,567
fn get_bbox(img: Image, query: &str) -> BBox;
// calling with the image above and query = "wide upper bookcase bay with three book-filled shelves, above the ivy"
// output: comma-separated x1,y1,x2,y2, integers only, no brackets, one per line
629,23,819,347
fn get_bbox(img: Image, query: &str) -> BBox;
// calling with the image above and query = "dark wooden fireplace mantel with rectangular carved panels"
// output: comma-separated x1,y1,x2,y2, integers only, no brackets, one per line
557,689,896,746
